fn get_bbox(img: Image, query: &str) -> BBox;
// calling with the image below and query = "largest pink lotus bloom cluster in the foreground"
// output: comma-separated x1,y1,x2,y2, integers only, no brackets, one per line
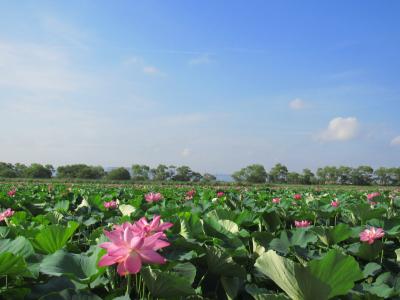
99,216,173,276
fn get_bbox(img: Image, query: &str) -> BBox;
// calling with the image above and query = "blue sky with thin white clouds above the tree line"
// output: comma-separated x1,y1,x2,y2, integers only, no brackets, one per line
0,0,400,174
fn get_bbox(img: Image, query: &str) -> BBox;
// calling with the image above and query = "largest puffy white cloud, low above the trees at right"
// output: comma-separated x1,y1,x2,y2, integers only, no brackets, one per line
318,117,359,141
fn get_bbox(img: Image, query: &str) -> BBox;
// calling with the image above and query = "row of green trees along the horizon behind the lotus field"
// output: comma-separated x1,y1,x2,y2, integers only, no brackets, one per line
0,162,400,186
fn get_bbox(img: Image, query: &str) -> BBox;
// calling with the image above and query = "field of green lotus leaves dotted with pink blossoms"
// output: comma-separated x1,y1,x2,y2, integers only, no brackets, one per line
0,183,400,300
